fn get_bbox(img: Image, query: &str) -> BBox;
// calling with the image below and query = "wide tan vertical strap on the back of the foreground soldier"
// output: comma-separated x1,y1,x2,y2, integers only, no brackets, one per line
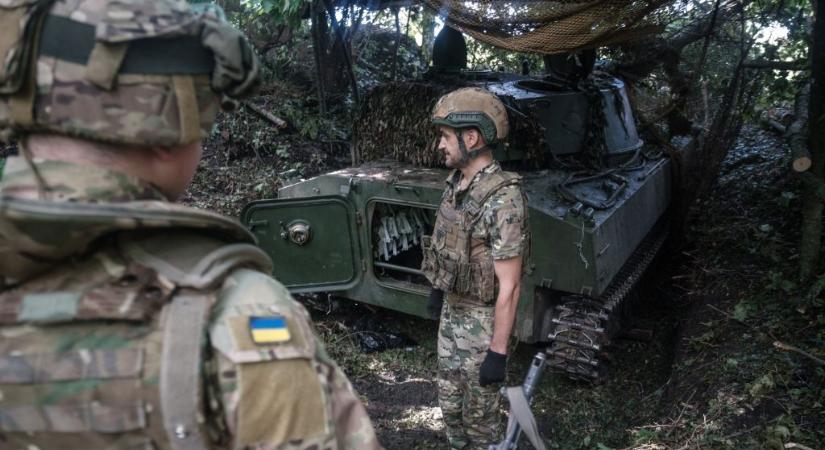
160,293,213,450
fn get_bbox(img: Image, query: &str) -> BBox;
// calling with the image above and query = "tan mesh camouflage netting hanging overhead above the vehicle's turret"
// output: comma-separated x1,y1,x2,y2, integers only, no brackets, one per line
425,0,670,54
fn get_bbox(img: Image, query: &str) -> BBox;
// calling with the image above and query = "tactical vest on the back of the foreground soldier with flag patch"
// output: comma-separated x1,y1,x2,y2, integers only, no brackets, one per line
0,205,271,450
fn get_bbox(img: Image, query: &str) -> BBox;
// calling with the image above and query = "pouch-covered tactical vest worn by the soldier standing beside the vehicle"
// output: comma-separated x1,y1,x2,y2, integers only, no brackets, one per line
421,171,521,305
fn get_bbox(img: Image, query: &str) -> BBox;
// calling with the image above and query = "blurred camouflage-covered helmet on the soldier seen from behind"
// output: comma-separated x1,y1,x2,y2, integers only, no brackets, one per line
0,0,259,146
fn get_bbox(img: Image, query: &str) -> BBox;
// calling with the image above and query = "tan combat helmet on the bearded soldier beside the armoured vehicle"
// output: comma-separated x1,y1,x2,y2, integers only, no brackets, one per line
432,87,510,164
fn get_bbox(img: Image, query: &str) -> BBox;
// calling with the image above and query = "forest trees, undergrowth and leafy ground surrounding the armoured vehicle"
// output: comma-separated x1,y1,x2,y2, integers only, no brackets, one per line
175,0,825,450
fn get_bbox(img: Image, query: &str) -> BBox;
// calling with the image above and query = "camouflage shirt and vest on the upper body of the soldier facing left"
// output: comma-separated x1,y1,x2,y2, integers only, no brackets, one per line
422,161,529,305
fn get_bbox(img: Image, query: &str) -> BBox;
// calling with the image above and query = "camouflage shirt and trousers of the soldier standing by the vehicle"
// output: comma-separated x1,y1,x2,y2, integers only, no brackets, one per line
424,162,529,449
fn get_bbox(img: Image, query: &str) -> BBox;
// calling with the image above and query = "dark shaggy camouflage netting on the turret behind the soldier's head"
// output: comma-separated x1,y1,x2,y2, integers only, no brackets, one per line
353,82,544,168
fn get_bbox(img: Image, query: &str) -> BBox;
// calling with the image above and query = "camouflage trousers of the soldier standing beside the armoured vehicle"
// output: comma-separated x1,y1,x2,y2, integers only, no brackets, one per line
438,302,503,450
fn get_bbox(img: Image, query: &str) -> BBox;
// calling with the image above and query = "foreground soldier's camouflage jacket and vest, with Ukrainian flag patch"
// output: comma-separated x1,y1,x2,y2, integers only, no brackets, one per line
0,158,380,450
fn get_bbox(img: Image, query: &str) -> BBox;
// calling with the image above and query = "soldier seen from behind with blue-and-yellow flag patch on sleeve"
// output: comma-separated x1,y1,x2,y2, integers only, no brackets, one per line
0,0,380,450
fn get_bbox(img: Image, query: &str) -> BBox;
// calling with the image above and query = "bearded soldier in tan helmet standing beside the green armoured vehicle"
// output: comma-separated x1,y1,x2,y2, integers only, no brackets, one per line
422,88,529,450
